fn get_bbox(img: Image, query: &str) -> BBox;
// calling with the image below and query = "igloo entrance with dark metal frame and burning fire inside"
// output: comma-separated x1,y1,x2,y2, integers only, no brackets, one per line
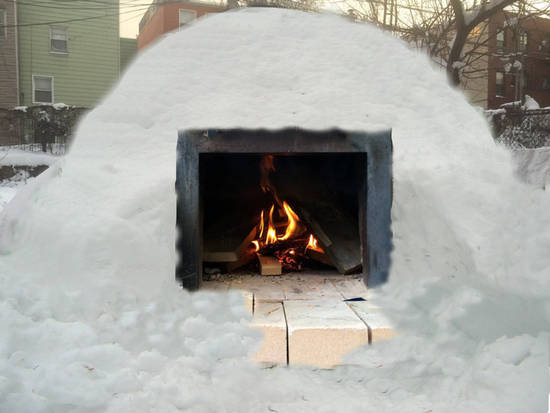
176,129,392,290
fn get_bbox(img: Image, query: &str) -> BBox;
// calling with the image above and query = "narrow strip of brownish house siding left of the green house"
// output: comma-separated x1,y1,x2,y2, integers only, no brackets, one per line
0,0,18,109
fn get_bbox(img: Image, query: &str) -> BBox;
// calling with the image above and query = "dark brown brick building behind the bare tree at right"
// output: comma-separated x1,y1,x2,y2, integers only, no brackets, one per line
487,13,550,109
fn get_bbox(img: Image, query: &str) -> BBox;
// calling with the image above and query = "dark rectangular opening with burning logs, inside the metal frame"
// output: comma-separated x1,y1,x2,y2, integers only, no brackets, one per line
199,153,365,279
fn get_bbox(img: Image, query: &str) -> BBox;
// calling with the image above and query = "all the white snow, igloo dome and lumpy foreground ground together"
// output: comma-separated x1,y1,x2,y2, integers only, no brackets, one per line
0,9,550,413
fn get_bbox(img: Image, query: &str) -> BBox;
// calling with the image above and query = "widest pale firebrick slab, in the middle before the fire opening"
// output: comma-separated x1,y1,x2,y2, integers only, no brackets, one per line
284,298,368,368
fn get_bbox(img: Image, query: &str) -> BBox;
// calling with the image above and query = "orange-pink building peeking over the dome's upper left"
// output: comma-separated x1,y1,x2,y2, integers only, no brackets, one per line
138,0,226,51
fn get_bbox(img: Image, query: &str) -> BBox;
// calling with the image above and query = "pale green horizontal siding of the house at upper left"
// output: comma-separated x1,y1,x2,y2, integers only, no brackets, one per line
18,0,120,107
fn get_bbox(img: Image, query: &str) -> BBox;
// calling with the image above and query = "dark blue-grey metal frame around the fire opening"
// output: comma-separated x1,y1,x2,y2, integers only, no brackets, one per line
176,128,392,290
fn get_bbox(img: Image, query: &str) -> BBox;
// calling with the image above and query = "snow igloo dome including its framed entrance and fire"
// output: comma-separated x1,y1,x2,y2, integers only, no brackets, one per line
2,8,511,298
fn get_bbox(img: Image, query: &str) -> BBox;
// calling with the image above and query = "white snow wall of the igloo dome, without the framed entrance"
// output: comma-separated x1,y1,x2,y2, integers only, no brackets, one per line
2,5,544,293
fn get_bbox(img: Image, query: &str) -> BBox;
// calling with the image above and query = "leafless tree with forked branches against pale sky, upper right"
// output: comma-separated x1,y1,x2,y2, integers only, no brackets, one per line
346,0,550,85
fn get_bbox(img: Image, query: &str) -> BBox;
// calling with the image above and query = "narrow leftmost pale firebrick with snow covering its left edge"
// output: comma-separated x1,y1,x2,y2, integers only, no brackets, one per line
251,302,287,365
